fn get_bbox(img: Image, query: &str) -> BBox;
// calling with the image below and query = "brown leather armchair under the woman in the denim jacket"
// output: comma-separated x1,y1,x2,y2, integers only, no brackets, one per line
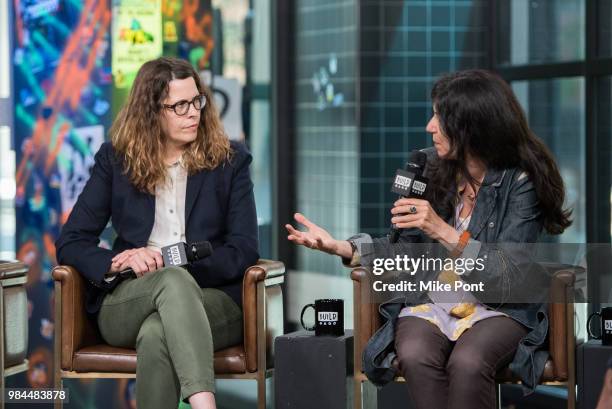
351,264,580,409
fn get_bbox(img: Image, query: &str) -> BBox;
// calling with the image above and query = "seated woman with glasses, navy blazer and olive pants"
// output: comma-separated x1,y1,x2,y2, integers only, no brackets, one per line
56,58,258,409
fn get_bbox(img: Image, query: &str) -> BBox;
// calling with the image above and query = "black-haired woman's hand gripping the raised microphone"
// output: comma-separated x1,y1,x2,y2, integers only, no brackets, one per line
391,198,459,244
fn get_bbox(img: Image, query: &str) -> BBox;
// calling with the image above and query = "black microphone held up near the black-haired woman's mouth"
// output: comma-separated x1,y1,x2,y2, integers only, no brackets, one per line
389,150,429,243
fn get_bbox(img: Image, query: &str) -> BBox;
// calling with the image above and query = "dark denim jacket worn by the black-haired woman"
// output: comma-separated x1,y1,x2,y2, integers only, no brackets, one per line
351,148,548,393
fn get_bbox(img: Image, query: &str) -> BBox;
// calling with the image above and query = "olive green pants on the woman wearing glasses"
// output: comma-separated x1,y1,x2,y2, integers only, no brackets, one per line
98,267,242,409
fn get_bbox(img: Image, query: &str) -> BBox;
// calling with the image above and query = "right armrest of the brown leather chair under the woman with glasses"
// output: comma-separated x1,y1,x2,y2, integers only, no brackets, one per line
242,259,285,372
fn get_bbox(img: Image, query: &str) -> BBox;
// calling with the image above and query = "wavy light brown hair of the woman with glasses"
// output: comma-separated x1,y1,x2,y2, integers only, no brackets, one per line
110,57,231,194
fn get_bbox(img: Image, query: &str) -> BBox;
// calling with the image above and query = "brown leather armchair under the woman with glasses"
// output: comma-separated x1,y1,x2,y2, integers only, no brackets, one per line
52,260,285,409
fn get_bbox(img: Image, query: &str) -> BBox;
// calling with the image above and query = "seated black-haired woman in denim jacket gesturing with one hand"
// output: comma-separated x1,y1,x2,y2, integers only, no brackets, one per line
286,70,571,409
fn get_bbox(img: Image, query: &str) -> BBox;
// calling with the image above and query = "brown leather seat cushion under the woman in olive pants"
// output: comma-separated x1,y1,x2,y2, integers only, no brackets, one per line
72,344,246,374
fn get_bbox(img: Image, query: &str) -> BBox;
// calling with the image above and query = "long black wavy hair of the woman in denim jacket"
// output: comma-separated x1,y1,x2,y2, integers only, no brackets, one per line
430,70,572,234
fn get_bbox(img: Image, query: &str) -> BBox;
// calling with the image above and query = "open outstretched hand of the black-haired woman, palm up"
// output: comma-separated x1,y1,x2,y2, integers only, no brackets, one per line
285,213,353,258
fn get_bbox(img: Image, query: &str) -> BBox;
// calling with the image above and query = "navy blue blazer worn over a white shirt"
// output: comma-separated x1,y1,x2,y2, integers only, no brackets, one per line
55,142,259,313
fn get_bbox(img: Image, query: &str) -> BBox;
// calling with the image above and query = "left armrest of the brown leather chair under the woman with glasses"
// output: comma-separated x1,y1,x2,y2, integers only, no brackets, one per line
51,266,100,371
